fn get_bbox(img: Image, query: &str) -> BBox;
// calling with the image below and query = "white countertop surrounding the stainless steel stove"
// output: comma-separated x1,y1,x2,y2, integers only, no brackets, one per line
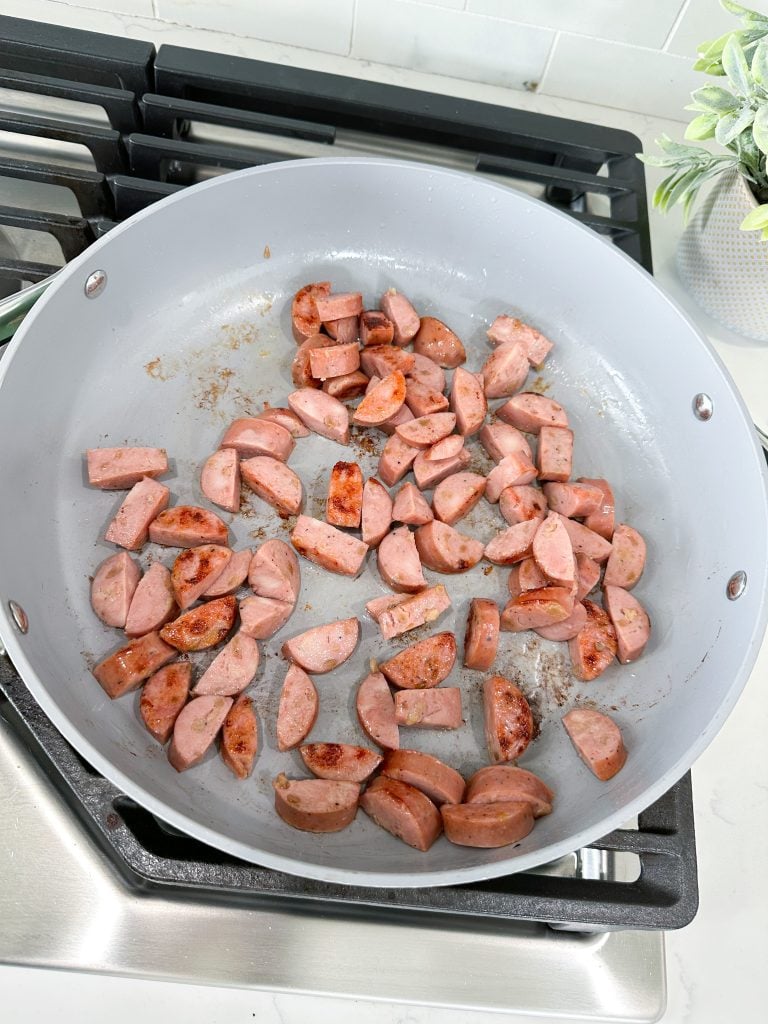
0,40,768,1024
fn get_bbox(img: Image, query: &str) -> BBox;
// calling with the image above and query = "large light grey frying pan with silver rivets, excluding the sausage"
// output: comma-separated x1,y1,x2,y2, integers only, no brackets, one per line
0,153,768,886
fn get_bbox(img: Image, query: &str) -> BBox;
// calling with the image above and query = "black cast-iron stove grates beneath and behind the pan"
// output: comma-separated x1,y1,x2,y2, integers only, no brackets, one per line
0,17,697,929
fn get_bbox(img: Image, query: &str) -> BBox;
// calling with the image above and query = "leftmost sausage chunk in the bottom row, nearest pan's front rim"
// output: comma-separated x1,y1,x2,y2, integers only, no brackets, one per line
272,773,360,833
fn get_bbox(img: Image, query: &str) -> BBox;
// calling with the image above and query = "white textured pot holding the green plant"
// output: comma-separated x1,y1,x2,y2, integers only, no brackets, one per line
677,170,768,342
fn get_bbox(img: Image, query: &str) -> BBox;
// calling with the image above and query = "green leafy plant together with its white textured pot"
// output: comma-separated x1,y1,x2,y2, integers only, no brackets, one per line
641,0,768,341
